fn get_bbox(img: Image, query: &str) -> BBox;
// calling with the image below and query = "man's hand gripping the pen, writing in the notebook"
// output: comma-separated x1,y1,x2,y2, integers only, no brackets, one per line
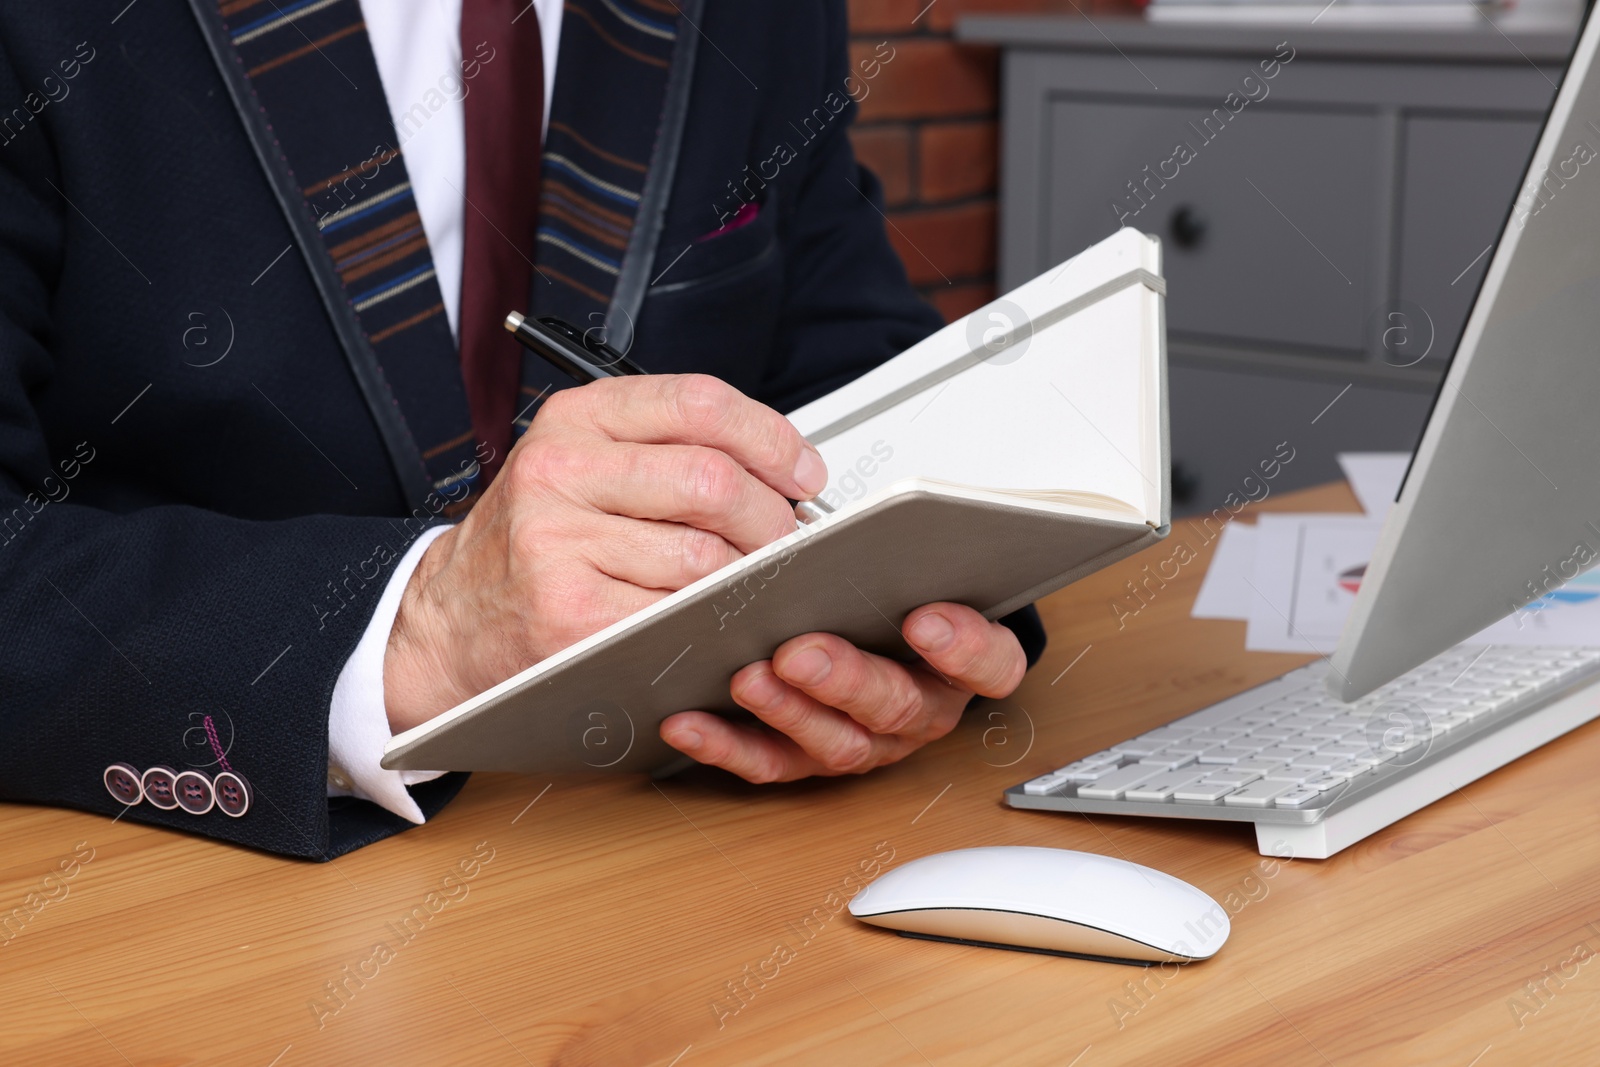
384,374,827,733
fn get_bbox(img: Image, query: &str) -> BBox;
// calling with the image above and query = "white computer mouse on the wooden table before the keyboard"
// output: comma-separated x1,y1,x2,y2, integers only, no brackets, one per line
850,846,1229,963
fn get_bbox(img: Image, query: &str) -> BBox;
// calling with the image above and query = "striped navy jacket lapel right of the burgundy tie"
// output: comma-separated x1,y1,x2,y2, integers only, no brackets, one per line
518,0,701,432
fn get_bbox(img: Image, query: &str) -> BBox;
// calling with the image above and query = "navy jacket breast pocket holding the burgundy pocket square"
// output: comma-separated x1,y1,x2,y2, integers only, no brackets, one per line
635,187,784,392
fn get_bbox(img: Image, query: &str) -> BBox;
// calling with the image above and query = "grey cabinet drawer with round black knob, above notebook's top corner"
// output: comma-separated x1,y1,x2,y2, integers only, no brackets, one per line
1043,98,1386,358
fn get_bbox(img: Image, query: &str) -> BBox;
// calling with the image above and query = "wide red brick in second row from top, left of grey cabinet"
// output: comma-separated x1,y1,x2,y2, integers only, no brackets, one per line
850,38,997,122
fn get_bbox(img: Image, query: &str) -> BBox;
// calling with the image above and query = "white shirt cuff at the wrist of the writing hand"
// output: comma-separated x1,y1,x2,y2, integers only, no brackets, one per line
328,526,450,824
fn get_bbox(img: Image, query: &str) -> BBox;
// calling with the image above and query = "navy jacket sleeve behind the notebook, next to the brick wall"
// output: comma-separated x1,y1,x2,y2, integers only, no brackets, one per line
760,0,1046,667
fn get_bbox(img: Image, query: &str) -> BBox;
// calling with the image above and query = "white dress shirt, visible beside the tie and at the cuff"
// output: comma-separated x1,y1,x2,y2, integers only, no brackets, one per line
328,0,562,822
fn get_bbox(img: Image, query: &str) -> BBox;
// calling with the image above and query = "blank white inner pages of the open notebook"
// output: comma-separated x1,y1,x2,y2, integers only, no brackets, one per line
789,229,1165,525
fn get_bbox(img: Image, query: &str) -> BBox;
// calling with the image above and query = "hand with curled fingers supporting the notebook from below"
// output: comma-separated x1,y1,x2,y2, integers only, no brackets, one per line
661,603,1027,782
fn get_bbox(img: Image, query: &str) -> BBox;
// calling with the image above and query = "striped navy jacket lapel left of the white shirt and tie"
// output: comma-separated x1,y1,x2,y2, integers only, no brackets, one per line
190,0,477,506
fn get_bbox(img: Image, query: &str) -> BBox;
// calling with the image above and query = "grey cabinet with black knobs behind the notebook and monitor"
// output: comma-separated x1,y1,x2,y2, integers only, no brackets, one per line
958,16,1576,514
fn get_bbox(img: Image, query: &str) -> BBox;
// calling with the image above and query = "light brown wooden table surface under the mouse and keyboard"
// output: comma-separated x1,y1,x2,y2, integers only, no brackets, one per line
0,485,1600,1067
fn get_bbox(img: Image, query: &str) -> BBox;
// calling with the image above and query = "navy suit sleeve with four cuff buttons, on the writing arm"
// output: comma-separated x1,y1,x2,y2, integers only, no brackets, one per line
0,93,464,859
